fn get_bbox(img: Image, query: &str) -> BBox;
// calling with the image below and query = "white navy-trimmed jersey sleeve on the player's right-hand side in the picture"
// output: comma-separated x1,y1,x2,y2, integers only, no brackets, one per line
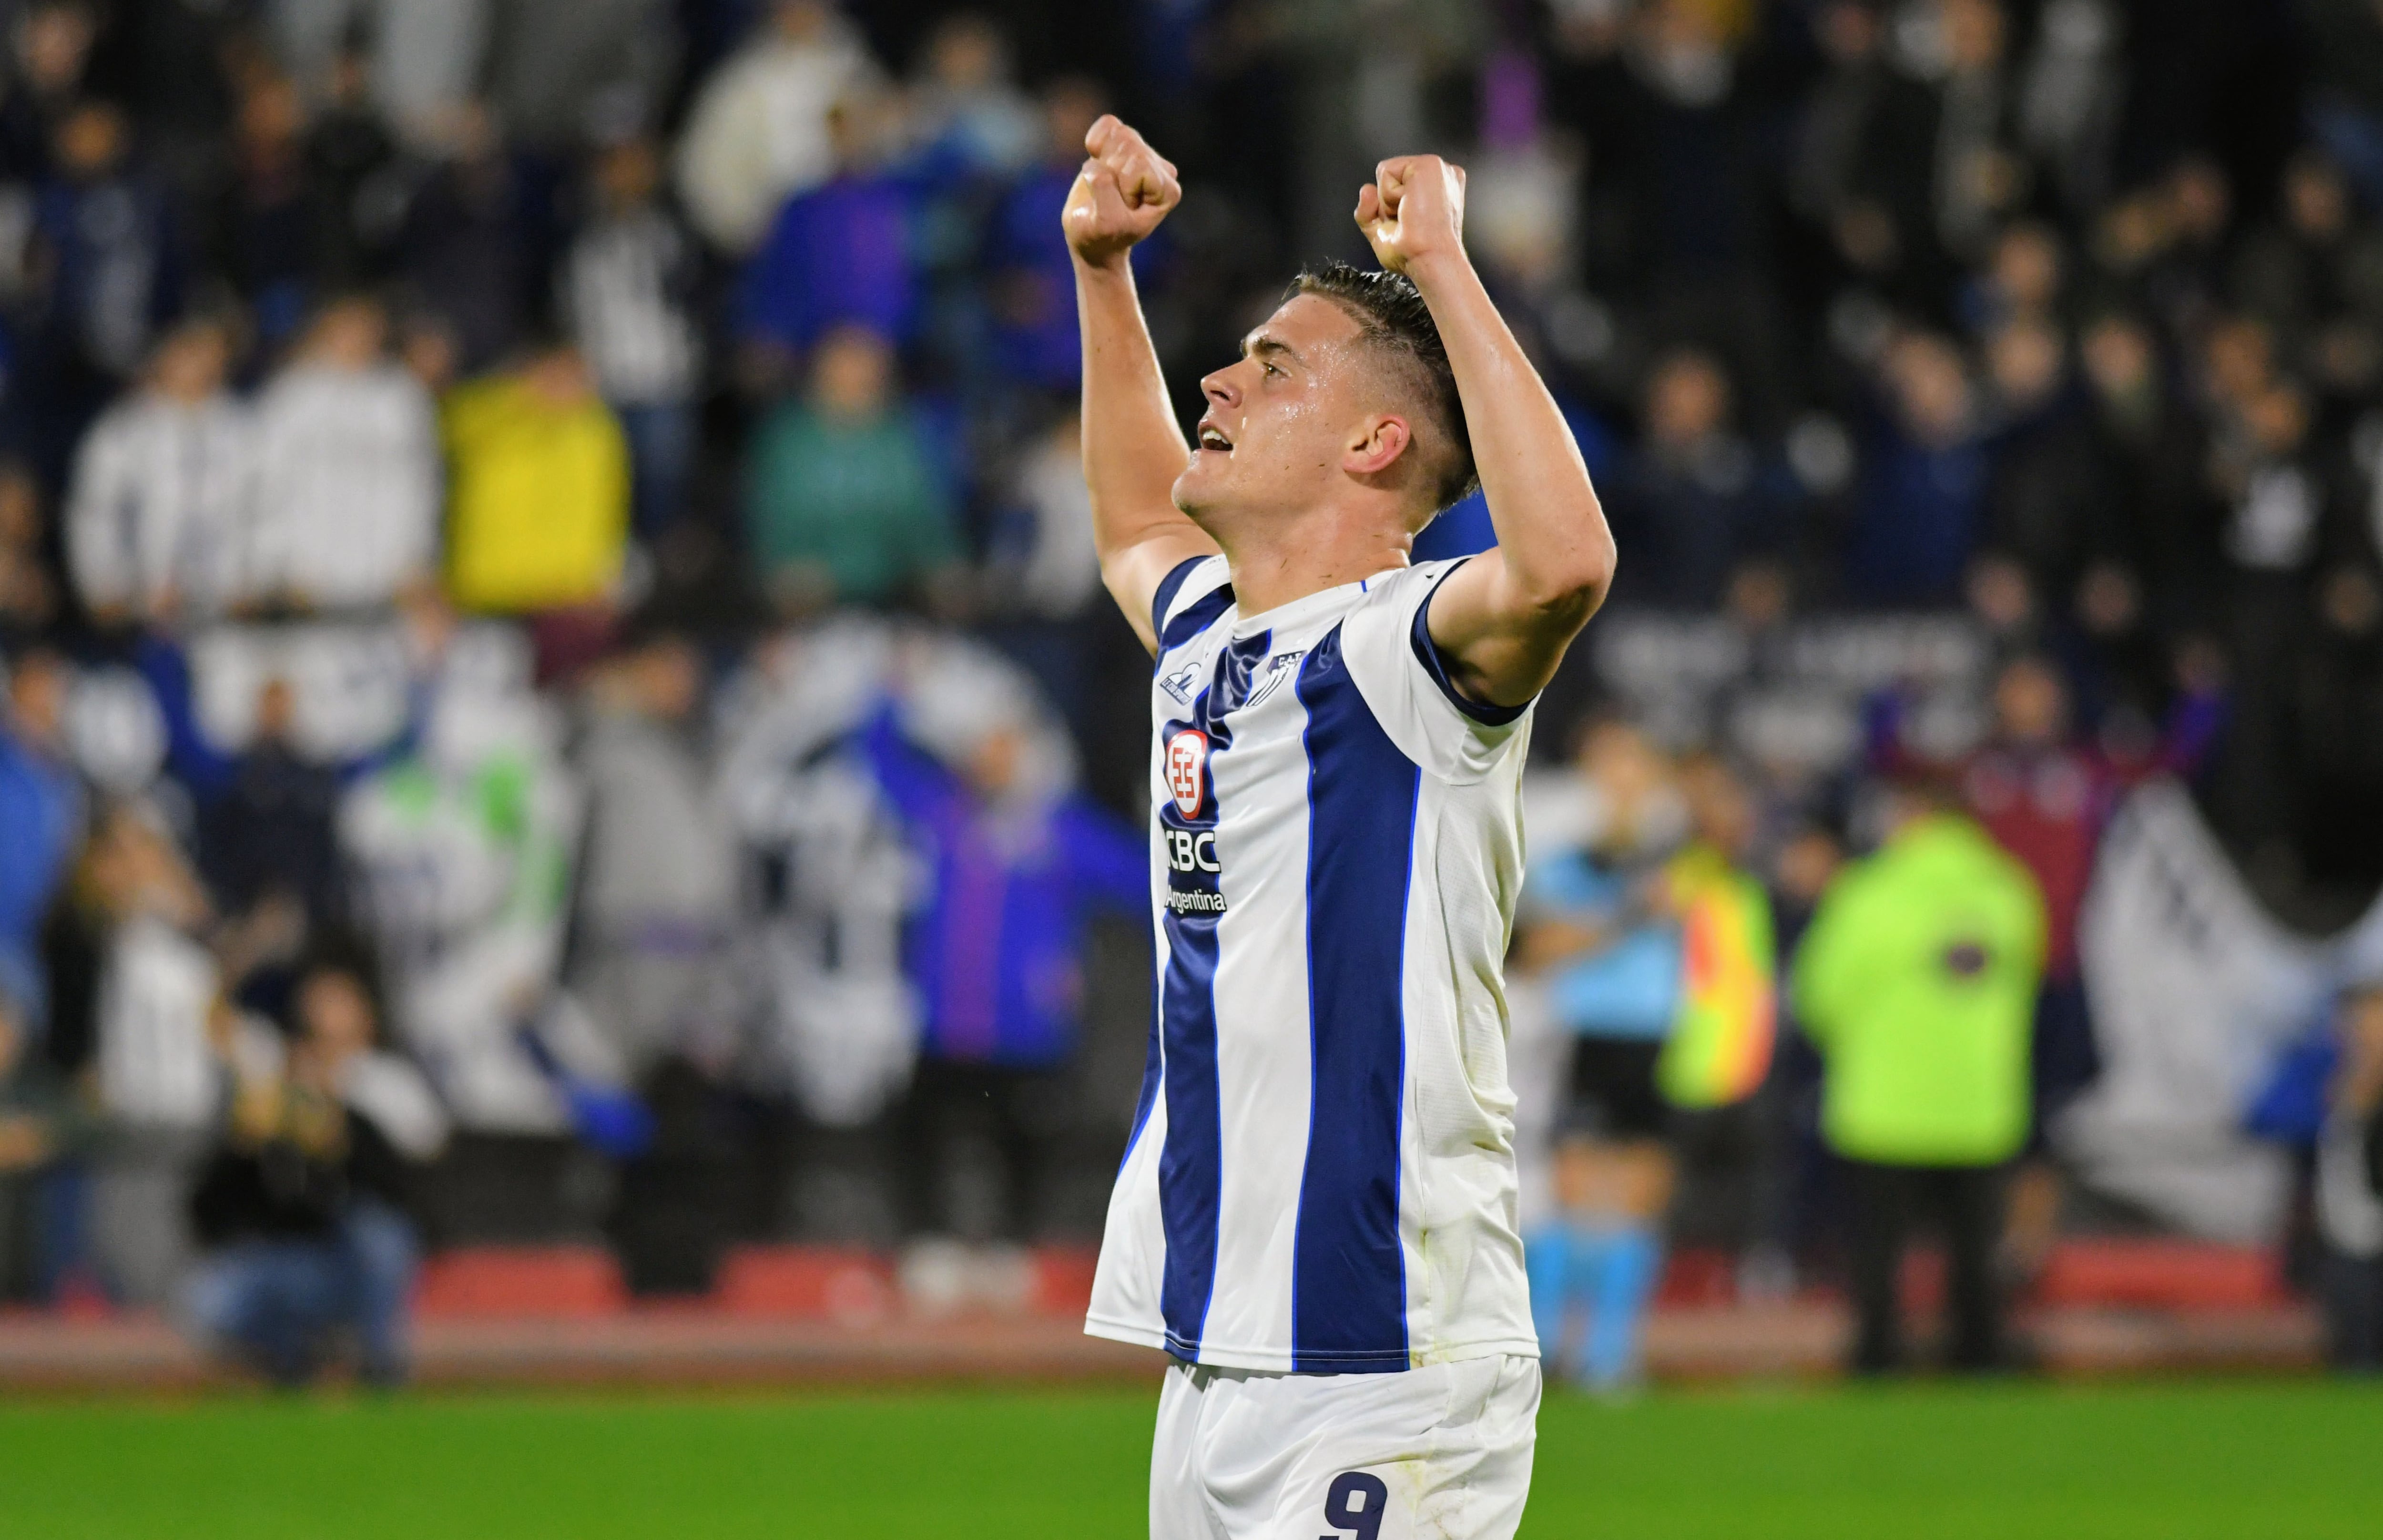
1342,558,1537,785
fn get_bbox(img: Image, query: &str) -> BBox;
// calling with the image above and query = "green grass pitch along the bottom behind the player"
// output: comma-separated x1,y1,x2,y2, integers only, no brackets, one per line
0,1383,2383,1540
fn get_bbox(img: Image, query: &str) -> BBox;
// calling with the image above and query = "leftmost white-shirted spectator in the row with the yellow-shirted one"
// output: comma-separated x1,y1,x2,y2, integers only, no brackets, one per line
67,319,257,624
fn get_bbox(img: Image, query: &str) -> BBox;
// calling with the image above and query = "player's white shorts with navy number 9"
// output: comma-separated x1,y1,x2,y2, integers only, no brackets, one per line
1151,1354,1539,1540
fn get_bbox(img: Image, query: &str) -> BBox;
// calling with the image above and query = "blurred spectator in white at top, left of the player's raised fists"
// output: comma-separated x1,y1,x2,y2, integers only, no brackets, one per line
677,0,879,257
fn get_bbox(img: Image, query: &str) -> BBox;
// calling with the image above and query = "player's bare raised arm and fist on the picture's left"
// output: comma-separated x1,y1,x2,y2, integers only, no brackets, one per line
1060,117,1218,653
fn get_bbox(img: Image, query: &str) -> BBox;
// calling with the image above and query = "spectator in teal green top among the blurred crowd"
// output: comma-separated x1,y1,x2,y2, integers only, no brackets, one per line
746,326,960,615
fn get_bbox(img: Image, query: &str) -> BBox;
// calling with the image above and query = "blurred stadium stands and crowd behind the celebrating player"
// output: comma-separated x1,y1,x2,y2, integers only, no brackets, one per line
0,0,2383,1387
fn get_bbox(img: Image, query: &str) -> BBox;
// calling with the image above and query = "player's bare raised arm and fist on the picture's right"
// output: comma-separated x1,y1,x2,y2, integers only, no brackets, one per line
1356,155,1613,705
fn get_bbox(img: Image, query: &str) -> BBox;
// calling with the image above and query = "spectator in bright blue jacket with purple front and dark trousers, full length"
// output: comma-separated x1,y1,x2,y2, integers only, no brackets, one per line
870,648,1151,1242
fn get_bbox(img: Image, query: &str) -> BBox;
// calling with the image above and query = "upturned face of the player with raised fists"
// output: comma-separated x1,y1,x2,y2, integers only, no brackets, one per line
1175,293,1365,534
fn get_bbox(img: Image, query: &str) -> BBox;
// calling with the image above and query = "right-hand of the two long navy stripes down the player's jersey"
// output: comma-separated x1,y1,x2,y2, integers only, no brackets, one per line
1292,627,1423,1373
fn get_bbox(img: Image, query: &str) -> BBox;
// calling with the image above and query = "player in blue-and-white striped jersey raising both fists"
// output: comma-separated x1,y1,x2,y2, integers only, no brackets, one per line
1063,117,1613,1540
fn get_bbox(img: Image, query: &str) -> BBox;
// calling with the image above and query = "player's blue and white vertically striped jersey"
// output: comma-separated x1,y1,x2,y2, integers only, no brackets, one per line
1087,558,1539,1373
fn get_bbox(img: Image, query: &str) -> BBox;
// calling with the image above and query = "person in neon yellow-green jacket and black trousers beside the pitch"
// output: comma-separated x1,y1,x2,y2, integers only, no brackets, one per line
1790,782,2045,1373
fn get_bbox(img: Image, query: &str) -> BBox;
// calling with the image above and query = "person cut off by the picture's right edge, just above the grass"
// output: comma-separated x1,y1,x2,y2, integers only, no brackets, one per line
2316,987,2383,1373
